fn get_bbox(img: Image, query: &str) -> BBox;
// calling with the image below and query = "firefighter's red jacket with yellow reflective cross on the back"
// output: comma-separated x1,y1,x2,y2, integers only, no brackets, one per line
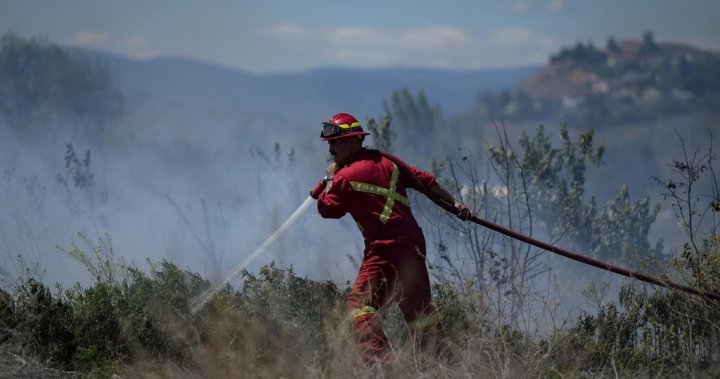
313,150,435,246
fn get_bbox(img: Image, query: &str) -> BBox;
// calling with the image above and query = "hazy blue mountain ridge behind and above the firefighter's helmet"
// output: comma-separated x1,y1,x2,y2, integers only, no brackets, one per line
83,47,540,117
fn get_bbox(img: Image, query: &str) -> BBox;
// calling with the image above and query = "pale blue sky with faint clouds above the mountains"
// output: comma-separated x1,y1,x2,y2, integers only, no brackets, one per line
0,0,720,73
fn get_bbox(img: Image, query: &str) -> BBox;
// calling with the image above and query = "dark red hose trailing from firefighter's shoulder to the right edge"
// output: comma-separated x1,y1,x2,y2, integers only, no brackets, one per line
381,152,720,300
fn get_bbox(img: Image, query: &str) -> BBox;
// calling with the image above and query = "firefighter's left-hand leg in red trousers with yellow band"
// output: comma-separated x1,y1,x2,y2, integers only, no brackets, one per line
347,254,393,363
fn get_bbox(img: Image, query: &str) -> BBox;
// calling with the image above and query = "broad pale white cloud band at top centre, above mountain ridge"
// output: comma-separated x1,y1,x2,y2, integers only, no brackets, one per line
262,24,562,69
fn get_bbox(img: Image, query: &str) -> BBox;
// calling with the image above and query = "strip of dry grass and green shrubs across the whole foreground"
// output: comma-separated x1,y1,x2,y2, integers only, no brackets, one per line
0,254,719,378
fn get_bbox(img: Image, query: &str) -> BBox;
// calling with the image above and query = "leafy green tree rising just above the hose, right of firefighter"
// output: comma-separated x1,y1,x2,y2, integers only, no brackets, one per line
490,125,662,264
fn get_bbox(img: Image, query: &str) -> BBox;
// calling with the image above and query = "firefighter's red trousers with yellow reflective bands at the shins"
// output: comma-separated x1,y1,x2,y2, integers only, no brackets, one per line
348,235,445,362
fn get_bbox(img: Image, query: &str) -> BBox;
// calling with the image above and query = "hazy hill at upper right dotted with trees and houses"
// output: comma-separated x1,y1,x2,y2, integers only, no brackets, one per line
466,33,720,126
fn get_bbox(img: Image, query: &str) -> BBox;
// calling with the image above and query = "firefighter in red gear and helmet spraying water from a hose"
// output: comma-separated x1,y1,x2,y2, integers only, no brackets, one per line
311,113,472,363
